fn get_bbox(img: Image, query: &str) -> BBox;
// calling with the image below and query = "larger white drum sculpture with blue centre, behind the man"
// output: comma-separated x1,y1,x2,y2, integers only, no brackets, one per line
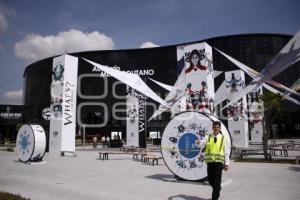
161,111,231,181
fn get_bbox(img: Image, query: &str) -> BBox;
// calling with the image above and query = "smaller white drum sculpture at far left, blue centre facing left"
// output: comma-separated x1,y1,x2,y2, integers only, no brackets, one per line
16,124,46,162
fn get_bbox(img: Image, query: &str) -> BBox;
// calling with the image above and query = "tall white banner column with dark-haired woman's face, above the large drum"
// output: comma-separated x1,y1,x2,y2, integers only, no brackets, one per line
182,42,215,113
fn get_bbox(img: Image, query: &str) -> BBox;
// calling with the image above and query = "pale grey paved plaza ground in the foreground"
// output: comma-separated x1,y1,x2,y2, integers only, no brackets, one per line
0,151,300,200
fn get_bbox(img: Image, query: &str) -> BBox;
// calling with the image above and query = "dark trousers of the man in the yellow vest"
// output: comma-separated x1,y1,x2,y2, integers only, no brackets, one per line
207,162,224,200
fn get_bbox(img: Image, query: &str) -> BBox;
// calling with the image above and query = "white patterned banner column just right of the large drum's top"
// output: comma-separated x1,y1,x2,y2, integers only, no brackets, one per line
225,70,249,147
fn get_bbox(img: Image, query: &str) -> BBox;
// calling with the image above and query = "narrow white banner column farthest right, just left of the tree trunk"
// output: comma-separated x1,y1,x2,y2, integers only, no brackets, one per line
247,87,263,143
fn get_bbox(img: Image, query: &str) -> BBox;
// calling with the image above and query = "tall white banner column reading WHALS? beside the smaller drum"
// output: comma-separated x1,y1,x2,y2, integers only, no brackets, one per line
49,55,78,153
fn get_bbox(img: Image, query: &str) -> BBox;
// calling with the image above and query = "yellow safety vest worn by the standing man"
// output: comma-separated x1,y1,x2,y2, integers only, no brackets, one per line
205,134,225,164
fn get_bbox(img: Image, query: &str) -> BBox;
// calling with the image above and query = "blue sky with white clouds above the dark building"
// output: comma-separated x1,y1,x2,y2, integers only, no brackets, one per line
0,0,300,104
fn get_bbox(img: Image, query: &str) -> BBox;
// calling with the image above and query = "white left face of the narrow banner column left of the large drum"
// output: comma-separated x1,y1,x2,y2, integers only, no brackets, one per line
126,86,139,146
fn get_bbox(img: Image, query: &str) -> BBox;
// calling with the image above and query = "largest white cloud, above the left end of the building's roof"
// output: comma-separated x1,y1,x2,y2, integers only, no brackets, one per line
15,29,114,62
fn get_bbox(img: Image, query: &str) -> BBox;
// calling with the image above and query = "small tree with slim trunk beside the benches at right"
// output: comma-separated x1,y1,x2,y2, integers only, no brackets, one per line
259,92,283,160
